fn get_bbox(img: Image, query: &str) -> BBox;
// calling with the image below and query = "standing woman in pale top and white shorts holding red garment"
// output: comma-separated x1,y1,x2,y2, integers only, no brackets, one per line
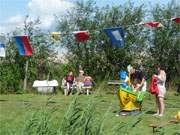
154,67,166,117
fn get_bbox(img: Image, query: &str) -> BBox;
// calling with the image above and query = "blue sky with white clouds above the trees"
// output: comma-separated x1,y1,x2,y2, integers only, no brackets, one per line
0,0,178,33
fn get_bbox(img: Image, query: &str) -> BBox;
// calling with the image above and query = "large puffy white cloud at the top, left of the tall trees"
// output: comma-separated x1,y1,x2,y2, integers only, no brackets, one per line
28,0,74,29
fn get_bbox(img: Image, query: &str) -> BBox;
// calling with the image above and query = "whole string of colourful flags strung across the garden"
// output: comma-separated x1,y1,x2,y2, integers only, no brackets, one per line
0,17,180,57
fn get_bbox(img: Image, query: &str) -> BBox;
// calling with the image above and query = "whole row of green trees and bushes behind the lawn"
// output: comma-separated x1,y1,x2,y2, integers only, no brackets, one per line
0,0,180,93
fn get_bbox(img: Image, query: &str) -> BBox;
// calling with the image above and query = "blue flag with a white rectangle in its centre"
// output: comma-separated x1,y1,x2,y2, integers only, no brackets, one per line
104,27,124,47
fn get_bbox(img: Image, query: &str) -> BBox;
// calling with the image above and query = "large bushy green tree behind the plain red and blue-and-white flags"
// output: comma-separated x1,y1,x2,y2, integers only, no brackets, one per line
57,0,145,78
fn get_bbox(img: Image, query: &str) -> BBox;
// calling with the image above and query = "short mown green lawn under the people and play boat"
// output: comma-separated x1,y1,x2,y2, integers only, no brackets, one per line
0,87,180,135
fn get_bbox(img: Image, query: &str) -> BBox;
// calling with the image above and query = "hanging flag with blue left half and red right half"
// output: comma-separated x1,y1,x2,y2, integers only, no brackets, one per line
15,36,32,56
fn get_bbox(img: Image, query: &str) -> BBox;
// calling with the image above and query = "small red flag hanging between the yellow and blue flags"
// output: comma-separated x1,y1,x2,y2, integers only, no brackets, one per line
74,31,89,42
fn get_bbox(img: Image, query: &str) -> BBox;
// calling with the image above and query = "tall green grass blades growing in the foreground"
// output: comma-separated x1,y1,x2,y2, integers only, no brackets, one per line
21,96,149,135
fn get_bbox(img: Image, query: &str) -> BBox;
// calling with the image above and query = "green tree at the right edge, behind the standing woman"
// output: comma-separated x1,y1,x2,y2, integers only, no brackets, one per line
149,1,180,85
